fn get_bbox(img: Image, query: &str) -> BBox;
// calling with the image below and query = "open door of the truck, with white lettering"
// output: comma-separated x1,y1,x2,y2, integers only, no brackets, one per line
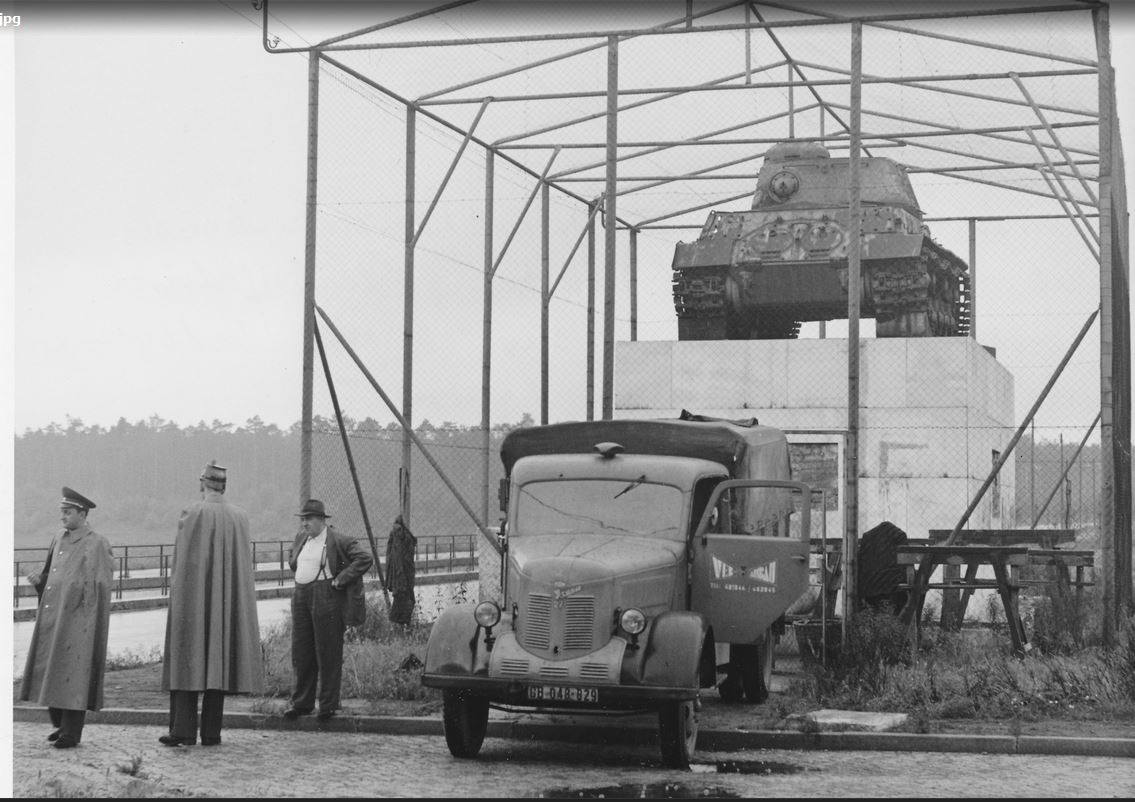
690,479,812,643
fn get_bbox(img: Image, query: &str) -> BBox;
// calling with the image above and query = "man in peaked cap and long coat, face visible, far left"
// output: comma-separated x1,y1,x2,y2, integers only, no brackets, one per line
19,488,114,749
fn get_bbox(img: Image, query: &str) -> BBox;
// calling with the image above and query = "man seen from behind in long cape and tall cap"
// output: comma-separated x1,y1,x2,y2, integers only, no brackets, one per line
158,461,264,746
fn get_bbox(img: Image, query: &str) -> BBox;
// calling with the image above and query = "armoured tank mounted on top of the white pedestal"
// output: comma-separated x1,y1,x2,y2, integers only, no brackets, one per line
673,142,969,340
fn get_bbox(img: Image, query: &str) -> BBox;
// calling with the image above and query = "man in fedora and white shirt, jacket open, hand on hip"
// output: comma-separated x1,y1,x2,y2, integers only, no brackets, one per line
284,498,373,721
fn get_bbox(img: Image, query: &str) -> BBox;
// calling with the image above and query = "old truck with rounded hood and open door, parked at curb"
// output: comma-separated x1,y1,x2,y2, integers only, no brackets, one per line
421,411,812,768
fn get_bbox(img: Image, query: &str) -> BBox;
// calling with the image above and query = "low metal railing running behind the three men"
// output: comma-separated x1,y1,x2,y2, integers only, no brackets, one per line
12,533,477,608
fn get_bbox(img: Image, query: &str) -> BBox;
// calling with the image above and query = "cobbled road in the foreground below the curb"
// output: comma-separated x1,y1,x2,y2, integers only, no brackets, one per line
11,721,1135,799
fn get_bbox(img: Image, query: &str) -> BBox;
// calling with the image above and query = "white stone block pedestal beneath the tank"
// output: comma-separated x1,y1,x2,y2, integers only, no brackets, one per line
614,337,1017,538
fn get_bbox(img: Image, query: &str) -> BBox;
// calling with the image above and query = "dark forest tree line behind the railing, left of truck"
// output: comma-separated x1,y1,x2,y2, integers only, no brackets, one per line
12,414,533,548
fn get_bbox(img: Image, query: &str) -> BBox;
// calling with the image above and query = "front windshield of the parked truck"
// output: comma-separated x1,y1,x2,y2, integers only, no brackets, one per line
512,476,684,540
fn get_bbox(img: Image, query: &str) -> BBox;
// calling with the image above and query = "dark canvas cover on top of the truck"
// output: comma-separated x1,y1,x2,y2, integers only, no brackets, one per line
501,410,790,479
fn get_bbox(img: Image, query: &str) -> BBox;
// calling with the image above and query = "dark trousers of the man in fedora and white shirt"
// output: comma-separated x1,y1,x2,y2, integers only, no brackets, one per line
292,580,347,712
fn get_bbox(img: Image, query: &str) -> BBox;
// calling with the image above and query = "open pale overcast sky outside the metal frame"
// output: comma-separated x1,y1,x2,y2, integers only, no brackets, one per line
0,0,1135,434
